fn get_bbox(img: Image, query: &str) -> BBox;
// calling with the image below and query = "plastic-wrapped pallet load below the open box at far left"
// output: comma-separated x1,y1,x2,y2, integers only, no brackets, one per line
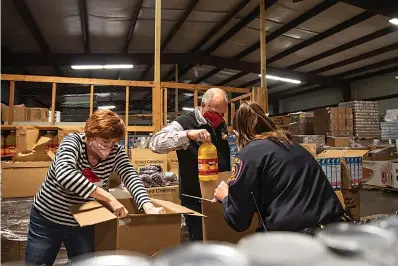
0,198,33,241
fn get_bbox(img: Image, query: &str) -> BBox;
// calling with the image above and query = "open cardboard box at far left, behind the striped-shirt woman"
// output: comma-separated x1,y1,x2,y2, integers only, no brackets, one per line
1,137,54,198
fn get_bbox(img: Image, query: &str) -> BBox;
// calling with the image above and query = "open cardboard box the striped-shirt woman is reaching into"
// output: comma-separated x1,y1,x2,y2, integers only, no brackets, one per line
70,191,203,256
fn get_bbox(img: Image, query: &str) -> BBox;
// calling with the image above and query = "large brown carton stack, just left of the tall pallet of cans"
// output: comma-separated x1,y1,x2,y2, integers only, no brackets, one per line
314,107,353,137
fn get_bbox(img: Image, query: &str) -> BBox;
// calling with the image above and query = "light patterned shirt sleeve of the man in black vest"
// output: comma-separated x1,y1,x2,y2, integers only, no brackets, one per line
149,121,189,153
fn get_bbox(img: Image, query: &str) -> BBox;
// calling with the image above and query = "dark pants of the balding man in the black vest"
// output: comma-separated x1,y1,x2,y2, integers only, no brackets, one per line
181,202,203,242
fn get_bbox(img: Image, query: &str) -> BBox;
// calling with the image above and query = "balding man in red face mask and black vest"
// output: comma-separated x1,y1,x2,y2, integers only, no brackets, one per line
149,88,231,241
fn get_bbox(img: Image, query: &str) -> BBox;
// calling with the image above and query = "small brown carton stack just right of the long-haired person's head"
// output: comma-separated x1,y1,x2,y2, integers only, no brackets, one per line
289,112,314,135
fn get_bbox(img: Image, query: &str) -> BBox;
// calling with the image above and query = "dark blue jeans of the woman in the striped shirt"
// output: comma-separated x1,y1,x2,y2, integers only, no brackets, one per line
25,207,94,265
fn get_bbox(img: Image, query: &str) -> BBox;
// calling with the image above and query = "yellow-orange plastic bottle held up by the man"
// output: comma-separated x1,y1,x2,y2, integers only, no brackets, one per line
198,142,218,181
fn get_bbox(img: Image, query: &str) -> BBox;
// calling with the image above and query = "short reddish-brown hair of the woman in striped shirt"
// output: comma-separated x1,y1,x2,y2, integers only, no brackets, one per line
84,109,126,139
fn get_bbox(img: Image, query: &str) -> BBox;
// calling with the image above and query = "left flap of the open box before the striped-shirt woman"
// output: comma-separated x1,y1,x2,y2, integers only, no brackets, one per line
69,201,117,227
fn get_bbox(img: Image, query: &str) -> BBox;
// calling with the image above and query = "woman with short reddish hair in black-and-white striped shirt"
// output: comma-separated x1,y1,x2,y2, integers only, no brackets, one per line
25,110,164,265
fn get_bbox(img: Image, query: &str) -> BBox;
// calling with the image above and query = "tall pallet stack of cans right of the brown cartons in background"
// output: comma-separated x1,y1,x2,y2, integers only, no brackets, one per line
339,101,380,139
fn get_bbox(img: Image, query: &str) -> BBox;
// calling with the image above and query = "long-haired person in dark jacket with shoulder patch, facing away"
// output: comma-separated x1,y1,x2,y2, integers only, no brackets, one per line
214,102,344,234
